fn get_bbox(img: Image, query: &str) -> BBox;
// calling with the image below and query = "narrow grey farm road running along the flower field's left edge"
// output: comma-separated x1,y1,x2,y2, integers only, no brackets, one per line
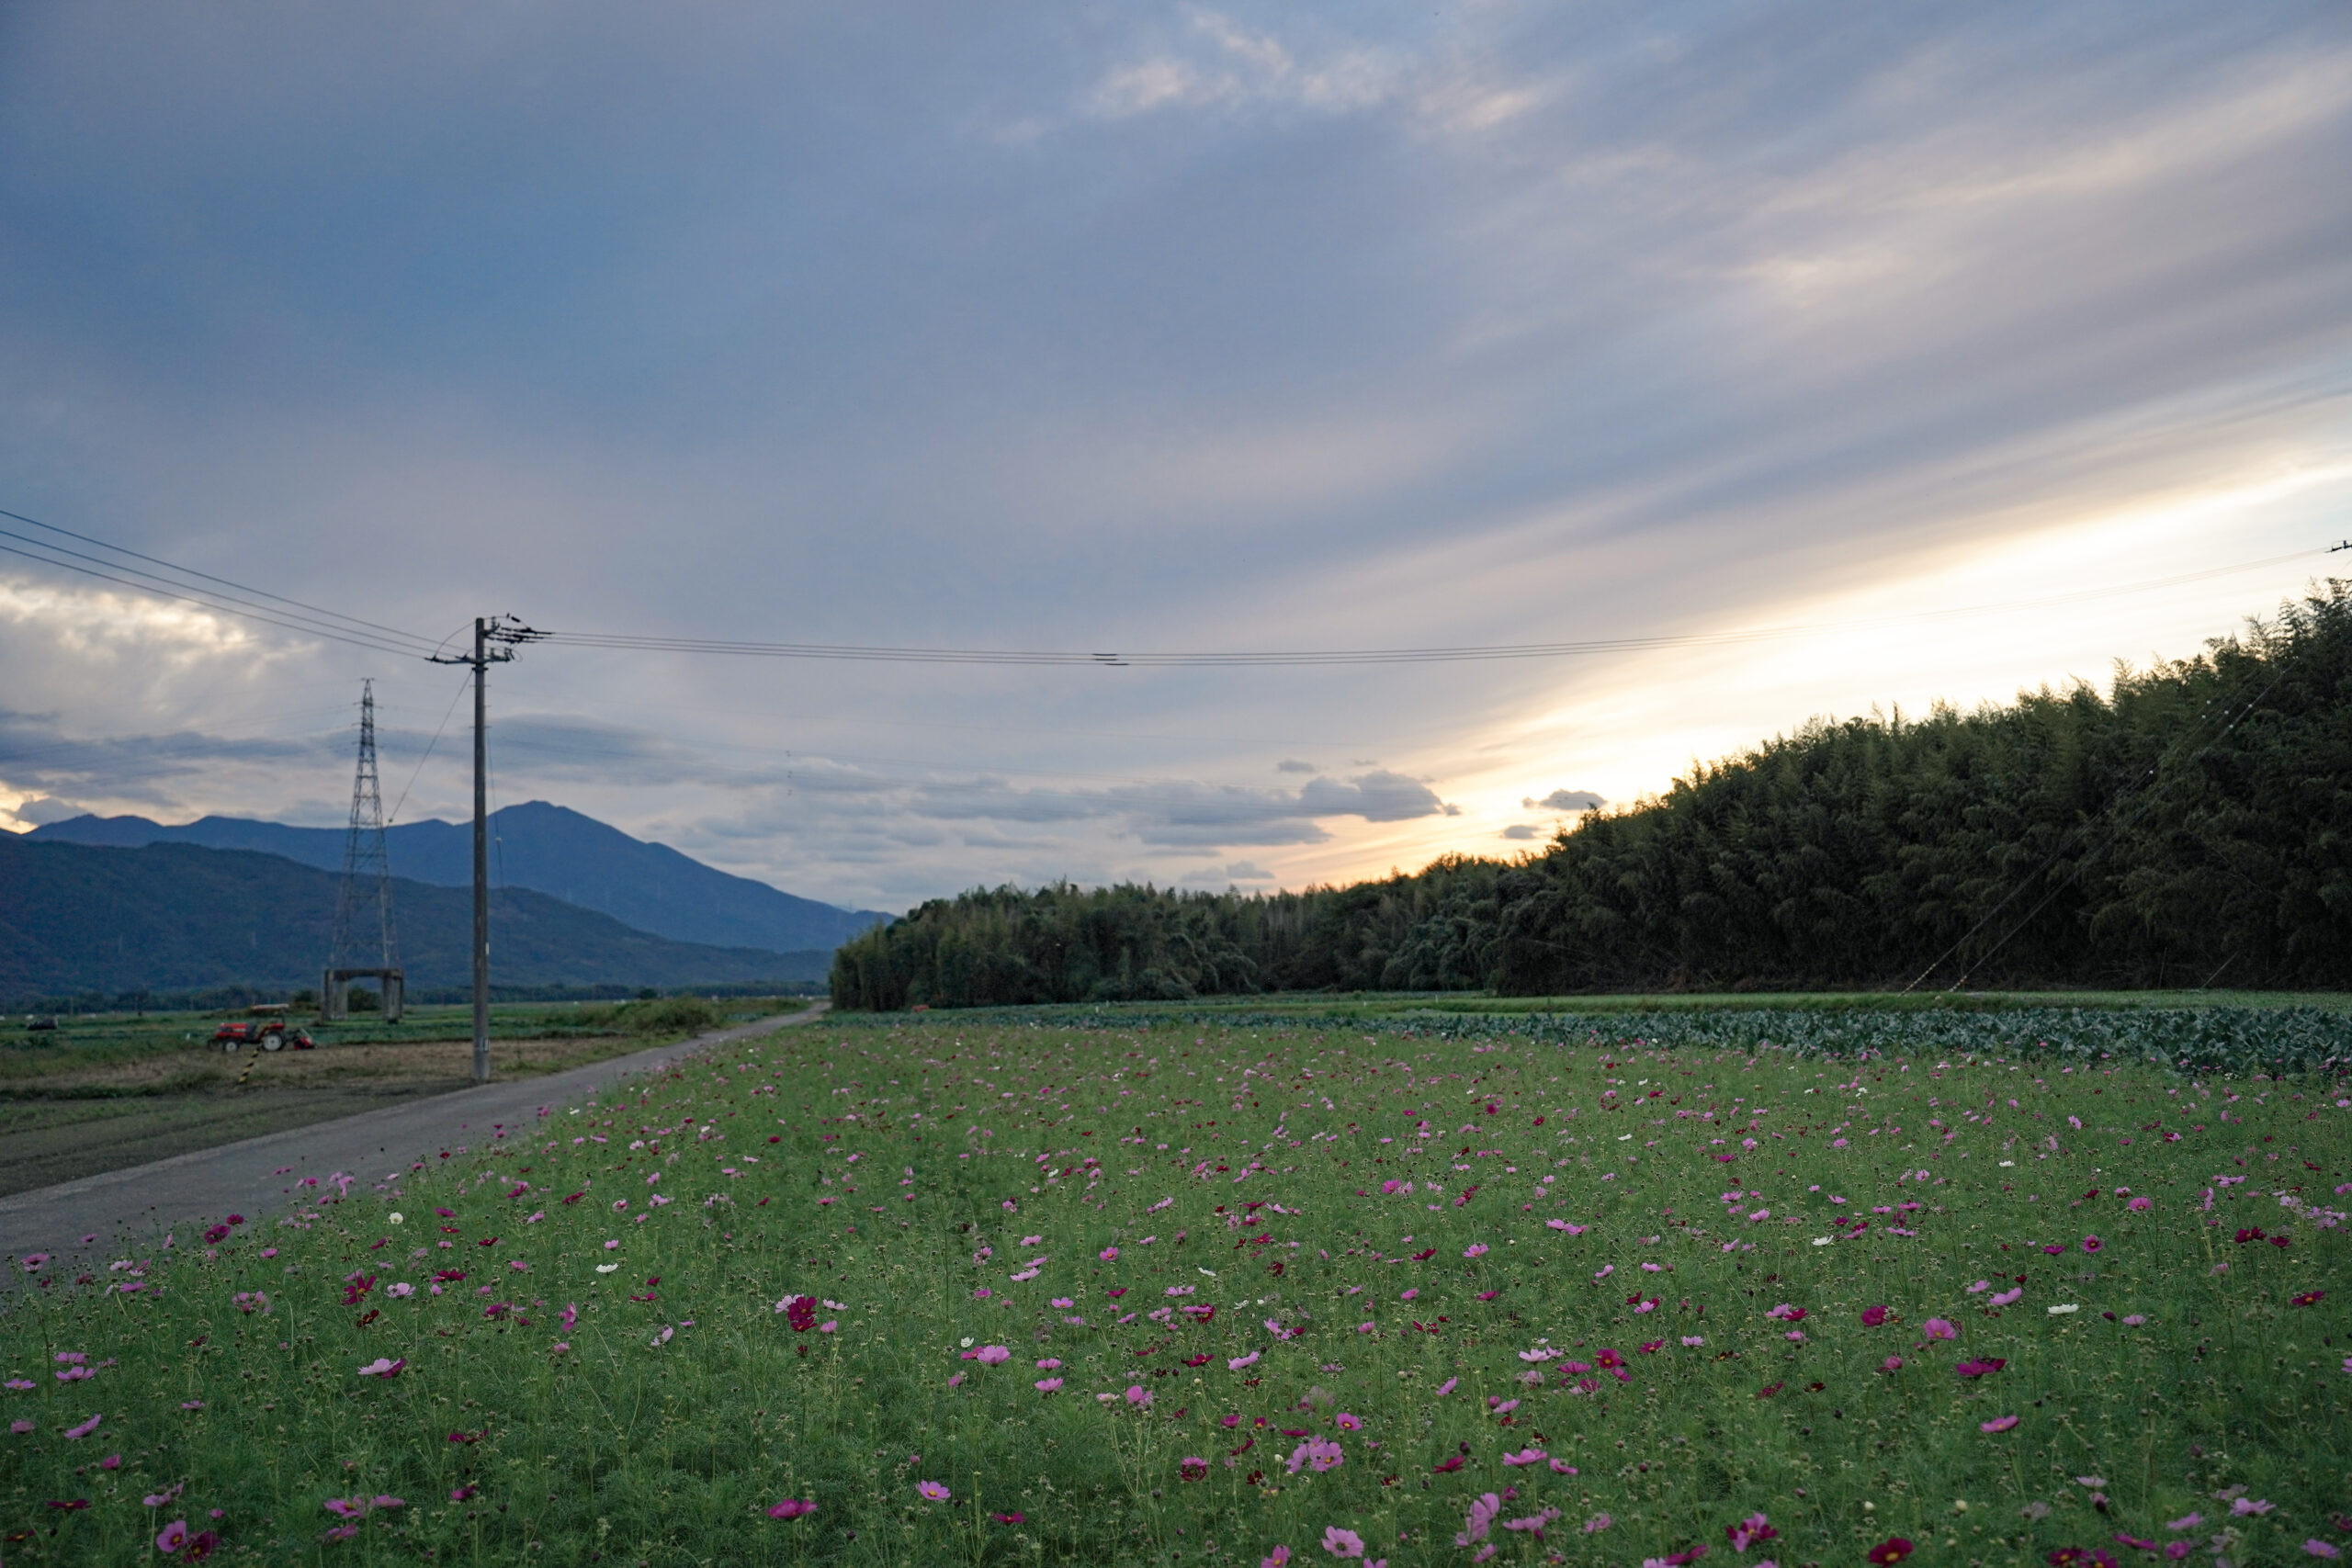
0,1001,826,1283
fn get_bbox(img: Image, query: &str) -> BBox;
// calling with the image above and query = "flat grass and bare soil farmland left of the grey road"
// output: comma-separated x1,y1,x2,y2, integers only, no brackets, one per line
0,999,802,1197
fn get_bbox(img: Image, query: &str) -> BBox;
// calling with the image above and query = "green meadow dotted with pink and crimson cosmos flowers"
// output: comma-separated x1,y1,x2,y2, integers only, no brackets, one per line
0,1016,2352,1568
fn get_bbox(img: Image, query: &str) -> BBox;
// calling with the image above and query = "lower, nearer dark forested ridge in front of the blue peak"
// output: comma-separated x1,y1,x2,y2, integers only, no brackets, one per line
0,832,831,1006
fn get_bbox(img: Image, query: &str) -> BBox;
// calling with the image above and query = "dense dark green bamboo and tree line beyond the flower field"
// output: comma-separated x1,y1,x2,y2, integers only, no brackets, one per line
831,581,2352,1009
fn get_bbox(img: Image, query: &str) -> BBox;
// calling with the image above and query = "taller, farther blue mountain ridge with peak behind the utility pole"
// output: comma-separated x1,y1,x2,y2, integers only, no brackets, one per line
24,799,889,952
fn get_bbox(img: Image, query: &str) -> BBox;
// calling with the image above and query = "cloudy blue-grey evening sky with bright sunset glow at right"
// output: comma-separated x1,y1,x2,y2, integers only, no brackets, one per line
0,0,2352,909
